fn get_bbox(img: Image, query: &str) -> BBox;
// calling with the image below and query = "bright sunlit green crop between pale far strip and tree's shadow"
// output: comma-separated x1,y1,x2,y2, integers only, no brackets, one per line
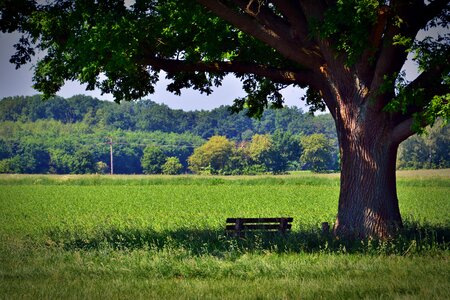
0,179,450,251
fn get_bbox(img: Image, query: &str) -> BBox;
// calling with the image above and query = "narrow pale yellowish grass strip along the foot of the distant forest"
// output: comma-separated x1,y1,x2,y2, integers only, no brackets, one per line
0,169,450,187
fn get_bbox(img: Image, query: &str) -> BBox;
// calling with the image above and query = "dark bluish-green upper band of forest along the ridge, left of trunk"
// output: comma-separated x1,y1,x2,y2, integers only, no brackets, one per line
0,95,336,141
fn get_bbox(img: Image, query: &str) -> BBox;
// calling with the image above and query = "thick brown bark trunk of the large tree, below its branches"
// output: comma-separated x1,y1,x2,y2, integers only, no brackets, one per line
334,108,402,239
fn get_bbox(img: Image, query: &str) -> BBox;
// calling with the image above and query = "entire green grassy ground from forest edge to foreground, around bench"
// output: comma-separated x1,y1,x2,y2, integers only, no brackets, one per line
0,170,450,299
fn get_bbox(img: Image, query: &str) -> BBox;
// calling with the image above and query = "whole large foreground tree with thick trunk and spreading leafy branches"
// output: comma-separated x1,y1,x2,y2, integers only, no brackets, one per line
0,0,450,238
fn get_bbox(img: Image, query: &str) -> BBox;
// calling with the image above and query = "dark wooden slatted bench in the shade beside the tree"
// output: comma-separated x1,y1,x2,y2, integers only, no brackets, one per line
226,218,294,236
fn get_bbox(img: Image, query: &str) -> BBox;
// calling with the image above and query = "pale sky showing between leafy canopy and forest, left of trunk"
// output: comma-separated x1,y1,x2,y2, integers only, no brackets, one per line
0,33,307,111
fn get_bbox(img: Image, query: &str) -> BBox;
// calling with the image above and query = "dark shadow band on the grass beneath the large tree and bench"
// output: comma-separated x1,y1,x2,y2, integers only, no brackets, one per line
47,223,450,257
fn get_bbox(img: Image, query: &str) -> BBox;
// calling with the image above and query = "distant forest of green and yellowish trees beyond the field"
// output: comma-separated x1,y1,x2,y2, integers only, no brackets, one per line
0,95,450,174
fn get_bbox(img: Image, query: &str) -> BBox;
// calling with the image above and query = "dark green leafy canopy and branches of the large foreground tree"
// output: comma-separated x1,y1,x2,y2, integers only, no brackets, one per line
0,0,449,125
